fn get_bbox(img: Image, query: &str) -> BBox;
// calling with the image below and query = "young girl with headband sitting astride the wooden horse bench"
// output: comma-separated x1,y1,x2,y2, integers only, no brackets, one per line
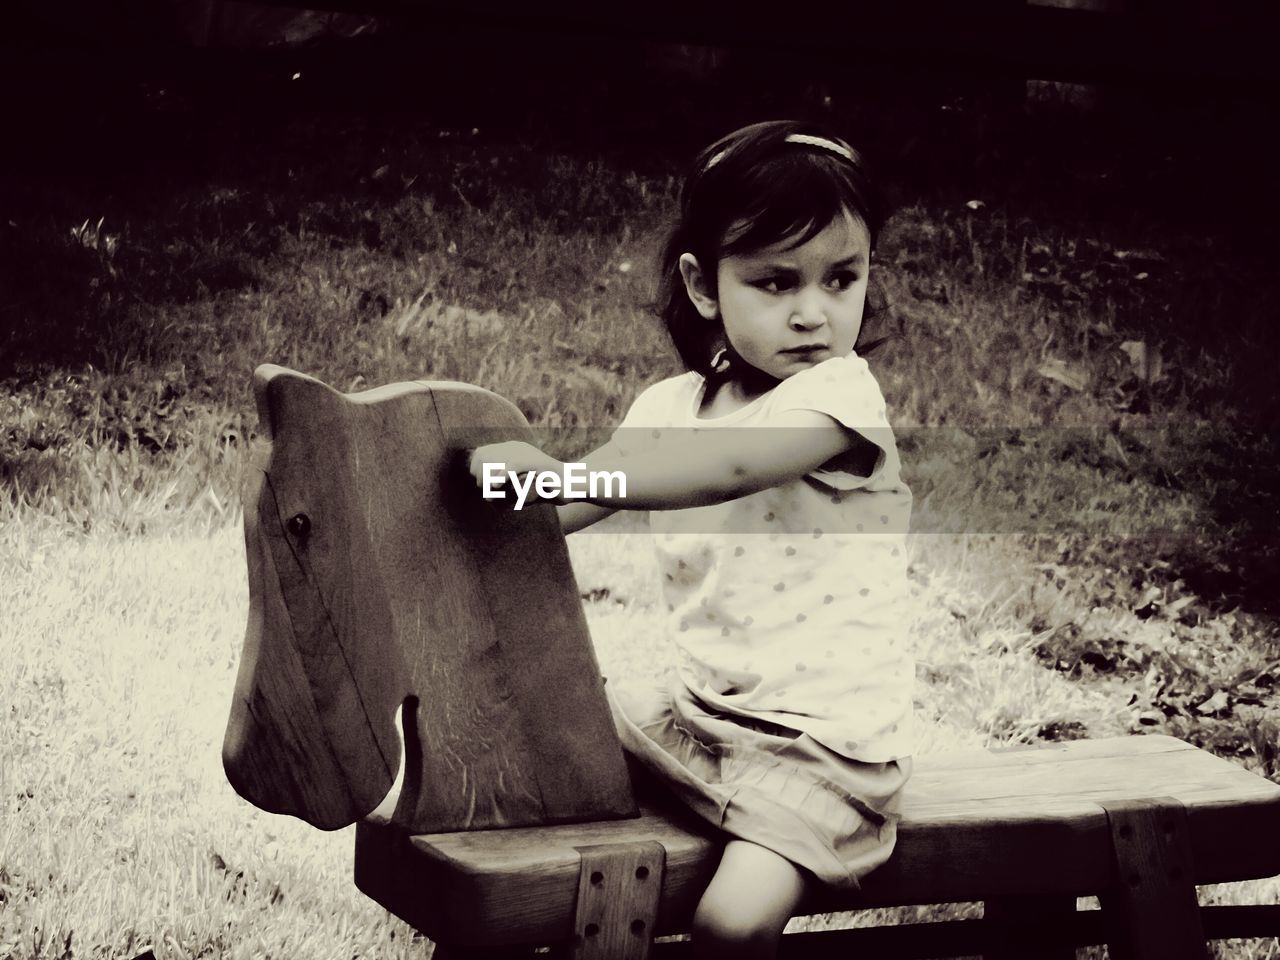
471,122,914,957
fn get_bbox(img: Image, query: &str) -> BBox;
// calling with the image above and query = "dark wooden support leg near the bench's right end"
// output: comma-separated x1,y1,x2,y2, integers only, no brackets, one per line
1101,797,1208,960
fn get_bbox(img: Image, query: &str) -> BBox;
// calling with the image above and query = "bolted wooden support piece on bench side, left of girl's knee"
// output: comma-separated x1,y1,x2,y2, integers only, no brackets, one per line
573,841,667,960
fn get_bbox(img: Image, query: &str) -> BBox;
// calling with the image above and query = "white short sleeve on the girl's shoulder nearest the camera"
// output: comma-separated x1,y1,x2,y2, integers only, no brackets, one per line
772,353,897,490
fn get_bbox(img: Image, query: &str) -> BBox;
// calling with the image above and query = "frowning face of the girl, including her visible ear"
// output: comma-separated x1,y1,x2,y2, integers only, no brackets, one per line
680,214,870,389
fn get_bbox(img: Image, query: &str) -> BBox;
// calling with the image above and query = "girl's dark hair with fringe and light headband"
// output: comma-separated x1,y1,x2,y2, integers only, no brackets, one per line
658,120,887,376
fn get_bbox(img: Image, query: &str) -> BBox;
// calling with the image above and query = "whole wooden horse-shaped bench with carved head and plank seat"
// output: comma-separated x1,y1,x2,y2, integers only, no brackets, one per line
223,366,1280,960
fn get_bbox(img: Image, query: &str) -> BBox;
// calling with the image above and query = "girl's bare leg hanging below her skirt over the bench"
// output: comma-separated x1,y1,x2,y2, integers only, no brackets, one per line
692,840,805,960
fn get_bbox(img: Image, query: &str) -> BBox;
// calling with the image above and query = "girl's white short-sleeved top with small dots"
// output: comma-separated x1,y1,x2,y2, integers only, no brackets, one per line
614,355,914,762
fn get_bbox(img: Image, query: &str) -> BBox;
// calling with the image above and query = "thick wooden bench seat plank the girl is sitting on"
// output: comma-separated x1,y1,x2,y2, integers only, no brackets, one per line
356,736,1280,943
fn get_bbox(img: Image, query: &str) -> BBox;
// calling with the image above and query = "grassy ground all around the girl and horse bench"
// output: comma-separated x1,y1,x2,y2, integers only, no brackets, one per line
0,30,1280,960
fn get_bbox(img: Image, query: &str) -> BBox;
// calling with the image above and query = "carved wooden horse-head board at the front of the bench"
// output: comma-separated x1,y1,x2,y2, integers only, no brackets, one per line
223,367,635,832
